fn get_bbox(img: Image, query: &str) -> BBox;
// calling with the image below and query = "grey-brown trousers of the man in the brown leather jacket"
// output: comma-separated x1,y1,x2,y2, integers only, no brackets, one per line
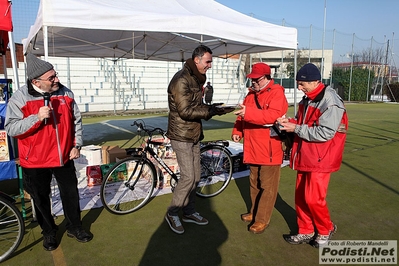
168,140,201,215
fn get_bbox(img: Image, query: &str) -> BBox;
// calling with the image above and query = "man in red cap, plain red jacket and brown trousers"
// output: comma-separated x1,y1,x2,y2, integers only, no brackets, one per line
231,63,288,234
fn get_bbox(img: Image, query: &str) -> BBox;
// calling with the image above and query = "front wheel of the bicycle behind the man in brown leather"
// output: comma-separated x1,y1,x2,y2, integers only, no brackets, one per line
100,157,156,214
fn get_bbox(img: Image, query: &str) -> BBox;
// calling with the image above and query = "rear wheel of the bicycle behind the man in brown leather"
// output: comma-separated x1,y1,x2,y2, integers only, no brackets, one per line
196,145,233,198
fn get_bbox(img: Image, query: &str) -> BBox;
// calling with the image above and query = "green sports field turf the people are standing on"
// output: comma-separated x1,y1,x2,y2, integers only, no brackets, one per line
2,103,399,266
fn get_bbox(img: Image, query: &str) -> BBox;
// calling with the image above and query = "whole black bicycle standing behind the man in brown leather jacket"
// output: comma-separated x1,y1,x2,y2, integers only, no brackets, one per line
100,120,233,214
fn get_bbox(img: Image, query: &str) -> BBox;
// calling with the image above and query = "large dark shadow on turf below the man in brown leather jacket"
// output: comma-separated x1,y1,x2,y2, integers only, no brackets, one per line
139,197,228,266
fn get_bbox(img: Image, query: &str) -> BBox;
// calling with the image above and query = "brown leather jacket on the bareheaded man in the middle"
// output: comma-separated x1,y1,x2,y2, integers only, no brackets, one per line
166,59,211,143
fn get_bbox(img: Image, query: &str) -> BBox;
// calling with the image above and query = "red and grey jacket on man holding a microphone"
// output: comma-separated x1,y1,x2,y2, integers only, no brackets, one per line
5,84,82,168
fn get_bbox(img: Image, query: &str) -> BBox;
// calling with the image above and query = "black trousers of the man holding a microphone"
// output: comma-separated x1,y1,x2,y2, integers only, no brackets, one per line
22,161,82,235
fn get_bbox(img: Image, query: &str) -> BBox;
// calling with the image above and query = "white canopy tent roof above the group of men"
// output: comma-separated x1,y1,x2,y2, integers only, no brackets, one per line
23,0,297,61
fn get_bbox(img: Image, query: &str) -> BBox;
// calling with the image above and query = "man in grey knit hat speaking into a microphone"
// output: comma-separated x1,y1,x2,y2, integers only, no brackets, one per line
5,54,93,251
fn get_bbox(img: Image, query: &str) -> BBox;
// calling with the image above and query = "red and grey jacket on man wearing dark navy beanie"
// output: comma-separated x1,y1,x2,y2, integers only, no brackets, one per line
290,84,348,173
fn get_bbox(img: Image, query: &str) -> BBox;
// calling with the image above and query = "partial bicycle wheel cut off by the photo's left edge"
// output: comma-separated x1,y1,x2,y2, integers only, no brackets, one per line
0,196,25,262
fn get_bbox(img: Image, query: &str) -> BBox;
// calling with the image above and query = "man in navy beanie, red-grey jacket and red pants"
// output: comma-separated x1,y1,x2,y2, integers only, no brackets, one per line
278,63,348,248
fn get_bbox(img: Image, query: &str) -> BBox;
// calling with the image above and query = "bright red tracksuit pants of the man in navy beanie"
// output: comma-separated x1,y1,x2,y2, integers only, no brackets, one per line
295,171,333,235
